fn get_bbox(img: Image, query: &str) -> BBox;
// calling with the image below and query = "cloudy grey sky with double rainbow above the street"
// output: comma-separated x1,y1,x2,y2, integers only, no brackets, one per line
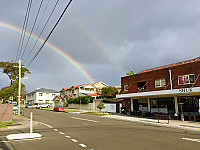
0,0,200,92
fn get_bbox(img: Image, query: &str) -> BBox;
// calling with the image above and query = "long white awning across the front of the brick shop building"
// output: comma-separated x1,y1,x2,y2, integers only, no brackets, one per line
116,87,200,99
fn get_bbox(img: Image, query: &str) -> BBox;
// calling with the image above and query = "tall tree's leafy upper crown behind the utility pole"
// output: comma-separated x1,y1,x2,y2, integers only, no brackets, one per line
0,61,30,86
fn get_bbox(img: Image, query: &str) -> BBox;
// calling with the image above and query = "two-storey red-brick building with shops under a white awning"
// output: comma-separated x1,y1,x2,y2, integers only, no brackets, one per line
117,57,200,120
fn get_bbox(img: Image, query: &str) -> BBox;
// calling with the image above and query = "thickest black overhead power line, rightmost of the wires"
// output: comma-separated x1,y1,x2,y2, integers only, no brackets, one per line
27,0,72,67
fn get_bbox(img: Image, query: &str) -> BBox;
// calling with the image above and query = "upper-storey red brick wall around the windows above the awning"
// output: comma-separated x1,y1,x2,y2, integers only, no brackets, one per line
121,62,200,93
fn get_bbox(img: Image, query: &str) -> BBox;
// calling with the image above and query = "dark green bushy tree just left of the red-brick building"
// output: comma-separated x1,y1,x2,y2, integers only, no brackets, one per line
101,86,118,98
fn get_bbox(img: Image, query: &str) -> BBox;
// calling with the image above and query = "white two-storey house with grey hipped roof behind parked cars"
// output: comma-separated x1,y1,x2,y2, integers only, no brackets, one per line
26,88,59,105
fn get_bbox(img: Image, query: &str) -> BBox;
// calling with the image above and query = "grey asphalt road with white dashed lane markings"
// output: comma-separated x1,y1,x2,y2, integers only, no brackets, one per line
0,108,200,150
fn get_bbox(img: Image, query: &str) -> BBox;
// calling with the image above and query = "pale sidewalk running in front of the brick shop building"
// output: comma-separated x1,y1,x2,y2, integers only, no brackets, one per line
102,114,200,131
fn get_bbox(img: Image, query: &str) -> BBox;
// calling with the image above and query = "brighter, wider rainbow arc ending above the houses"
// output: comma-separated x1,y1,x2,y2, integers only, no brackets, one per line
0,22,94,83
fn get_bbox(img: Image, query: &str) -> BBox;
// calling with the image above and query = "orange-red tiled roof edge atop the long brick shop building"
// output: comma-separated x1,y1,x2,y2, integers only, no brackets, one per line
137,57,200,74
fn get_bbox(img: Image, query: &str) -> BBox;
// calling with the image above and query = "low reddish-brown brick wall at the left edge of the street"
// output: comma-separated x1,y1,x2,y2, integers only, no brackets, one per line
0,104,13,122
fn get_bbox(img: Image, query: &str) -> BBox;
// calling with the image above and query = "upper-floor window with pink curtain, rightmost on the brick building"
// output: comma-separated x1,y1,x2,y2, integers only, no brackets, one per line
178,74,195,85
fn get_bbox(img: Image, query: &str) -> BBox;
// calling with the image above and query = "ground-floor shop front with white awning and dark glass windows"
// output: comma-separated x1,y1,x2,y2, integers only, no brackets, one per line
117,87,200,121
